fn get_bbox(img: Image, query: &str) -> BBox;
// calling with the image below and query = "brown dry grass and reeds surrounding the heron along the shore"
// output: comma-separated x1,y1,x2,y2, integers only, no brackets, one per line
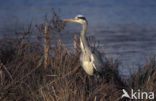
0,11,156,101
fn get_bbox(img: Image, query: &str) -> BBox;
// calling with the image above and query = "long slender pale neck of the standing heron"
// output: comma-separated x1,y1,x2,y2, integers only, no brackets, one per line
80,23,89,51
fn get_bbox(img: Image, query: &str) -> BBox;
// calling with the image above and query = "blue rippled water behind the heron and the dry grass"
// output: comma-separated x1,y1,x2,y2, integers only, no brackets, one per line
0,0,156,74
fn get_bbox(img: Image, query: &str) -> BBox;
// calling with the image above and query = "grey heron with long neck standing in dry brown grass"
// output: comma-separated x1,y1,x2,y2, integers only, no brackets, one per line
63,15,103,75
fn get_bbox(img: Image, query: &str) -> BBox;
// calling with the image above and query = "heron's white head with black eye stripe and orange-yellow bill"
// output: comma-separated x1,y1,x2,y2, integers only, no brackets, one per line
63,15,87,24
